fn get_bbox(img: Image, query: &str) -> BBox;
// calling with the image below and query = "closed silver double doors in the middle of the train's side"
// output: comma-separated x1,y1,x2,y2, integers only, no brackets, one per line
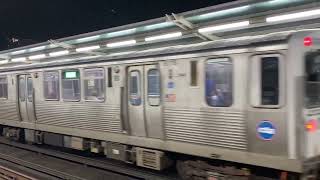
128,65,163,139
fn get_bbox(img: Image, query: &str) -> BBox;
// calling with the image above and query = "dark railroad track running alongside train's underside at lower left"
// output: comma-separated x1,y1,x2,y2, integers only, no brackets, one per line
0,137,178,180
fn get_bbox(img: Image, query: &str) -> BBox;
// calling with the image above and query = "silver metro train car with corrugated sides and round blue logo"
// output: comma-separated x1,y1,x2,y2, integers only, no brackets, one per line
0,0,320,179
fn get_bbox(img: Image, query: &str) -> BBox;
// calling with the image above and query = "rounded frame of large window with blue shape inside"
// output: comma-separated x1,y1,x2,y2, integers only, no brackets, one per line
203,56,235,108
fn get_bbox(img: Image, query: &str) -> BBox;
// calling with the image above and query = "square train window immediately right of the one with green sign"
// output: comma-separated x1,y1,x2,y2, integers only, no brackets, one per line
84,68,105,101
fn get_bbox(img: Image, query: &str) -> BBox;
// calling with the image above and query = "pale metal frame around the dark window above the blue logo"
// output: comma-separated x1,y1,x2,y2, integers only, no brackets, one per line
248,53,286,109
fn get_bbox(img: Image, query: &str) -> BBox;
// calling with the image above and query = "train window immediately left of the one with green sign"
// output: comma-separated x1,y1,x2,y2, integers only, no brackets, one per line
44,71,60,100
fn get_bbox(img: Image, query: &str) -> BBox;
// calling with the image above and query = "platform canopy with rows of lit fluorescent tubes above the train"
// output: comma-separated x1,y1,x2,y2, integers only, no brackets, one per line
0,0,320,71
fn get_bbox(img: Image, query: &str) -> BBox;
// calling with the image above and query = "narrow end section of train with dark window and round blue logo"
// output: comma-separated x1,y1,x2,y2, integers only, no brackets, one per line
248,54,288,156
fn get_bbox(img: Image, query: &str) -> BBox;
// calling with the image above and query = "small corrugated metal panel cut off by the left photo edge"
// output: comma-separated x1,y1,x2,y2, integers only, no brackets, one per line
0,101,19,121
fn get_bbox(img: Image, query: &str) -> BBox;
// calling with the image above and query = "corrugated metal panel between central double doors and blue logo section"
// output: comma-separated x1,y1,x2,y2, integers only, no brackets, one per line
164,108,247,150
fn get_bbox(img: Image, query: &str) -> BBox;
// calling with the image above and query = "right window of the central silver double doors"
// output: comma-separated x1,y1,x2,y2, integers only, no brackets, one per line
148,69,160,106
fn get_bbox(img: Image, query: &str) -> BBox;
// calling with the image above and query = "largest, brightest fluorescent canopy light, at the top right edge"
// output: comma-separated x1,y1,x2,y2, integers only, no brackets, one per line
266,9,320,22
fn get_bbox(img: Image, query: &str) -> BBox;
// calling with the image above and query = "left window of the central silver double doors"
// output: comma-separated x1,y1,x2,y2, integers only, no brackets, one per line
129,71,141,106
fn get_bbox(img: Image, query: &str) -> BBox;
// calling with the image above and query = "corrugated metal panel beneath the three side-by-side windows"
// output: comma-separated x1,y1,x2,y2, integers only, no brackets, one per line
36,101,121,133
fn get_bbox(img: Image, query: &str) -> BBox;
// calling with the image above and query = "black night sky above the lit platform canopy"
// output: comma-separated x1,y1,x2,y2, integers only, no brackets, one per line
0,0,232,50
